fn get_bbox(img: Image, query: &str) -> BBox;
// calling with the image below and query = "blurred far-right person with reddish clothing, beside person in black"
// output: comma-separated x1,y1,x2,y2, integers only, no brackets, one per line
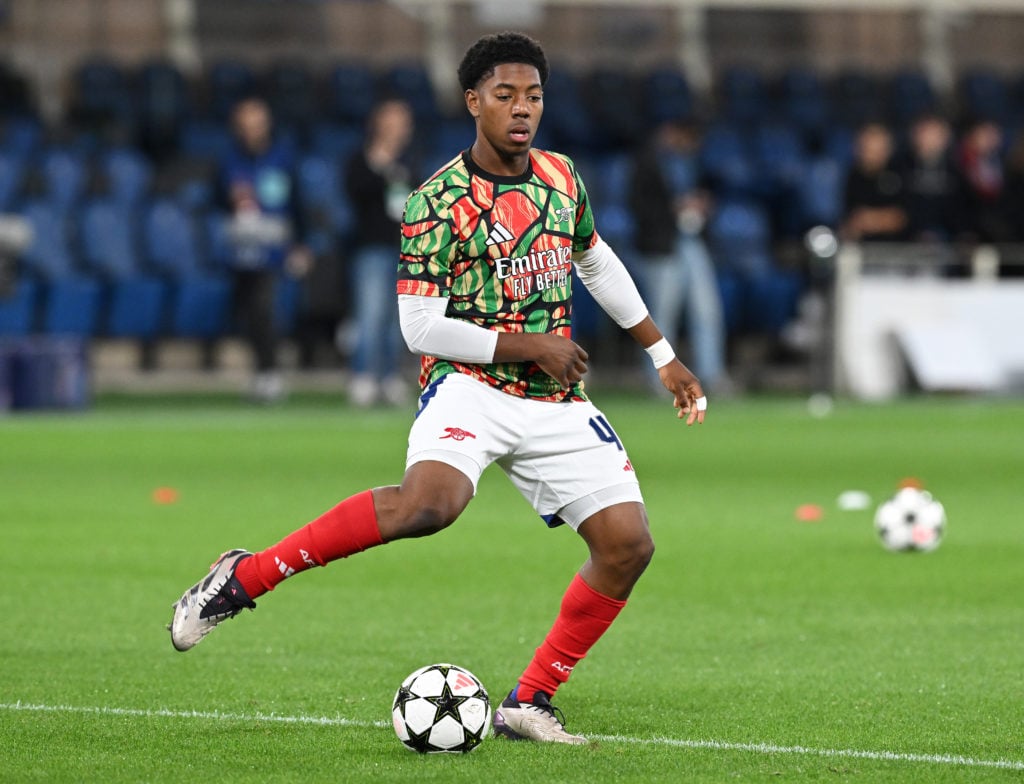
956,120,1019,243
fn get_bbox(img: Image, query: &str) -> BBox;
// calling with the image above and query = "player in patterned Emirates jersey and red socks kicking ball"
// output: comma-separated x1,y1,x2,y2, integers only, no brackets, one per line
170,33,708,744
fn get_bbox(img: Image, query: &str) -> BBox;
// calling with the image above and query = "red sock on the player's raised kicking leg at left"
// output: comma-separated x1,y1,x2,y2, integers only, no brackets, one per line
234,490,384,599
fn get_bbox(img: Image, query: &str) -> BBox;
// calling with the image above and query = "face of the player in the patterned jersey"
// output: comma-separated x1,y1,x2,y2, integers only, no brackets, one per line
466,62,544,174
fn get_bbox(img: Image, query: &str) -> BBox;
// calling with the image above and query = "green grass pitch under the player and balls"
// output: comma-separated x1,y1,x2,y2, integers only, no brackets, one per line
0,394,1024,782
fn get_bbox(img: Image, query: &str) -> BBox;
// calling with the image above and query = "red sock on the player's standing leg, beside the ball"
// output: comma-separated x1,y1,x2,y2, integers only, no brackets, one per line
517,574,626,702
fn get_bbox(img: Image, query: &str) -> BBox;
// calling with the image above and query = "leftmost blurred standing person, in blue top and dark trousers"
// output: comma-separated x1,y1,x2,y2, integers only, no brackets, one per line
220,98,311,402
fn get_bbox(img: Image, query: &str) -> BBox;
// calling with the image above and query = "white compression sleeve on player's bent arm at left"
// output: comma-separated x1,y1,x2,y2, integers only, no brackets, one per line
398,294,498,363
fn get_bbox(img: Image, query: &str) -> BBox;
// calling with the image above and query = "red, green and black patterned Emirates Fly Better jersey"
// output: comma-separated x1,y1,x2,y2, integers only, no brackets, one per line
398,149,597,401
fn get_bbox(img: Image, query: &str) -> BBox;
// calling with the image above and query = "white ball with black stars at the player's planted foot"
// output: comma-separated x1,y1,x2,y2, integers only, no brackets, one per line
391,664,490,754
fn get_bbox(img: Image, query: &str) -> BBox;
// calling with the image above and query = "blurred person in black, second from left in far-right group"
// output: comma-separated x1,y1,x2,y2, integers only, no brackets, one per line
897,114,961,243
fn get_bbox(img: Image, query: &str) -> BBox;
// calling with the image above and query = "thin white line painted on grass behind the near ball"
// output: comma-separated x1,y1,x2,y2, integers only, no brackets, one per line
0,701,1024,771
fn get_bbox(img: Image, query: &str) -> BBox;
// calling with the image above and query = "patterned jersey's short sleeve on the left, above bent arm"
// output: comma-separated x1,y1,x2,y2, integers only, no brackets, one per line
397,190,456,297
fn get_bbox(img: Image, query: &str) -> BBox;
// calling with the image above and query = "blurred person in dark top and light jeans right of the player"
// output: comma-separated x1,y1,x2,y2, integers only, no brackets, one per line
629,121,730,392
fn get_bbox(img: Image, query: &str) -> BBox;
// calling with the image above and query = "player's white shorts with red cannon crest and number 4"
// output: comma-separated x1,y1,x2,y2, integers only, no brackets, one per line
406,373,643,529
